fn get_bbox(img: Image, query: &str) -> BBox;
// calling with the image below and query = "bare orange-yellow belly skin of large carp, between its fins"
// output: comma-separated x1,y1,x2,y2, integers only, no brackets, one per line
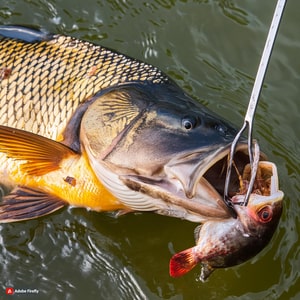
4,154,126,211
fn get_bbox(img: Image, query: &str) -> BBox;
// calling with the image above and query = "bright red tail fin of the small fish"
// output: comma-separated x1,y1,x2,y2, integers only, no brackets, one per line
170,248,198,277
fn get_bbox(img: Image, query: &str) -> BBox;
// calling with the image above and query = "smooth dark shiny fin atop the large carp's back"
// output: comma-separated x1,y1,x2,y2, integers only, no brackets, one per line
0,25,52,43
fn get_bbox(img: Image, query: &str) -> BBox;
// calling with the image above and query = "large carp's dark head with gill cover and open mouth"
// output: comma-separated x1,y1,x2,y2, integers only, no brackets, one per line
80,83,266,222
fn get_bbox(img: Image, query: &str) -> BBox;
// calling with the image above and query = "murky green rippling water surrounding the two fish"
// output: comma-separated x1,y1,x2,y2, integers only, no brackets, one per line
0,0,300,300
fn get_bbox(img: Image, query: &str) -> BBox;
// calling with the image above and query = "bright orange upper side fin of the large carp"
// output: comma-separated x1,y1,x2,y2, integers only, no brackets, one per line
0,125,78,176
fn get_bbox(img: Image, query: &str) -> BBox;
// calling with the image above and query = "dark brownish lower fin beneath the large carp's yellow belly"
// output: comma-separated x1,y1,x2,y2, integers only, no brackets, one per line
0,186,67,223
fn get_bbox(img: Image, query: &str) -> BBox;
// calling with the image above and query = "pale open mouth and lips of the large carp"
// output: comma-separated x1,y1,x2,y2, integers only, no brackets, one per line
116,143,265,222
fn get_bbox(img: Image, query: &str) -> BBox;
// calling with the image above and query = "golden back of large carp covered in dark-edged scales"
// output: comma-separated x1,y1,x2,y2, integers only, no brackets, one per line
0,35,169,139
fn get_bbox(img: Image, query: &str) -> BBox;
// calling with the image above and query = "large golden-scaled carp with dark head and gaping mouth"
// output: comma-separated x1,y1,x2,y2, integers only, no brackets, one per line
0,26,282,222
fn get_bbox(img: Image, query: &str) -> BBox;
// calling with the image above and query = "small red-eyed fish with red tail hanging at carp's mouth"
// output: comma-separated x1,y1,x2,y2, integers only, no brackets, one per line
170,162,283,281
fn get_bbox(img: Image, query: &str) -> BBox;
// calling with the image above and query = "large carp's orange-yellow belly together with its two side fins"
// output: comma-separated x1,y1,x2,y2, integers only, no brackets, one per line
0,125,127,223
